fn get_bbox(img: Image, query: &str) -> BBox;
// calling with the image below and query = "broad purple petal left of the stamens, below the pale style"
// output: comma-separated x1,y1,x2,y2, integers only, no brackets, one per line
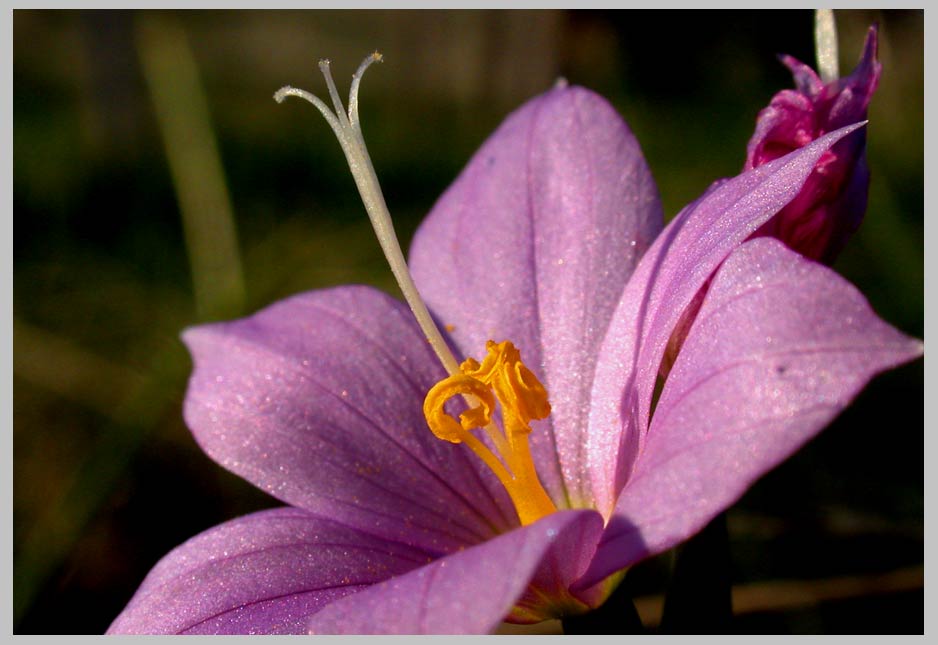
184,287,518,553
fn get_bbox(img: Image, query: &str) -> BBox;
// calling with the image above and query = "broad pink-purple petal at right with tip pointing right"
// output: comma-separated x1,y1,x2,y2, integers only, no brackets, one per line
583,238,922,583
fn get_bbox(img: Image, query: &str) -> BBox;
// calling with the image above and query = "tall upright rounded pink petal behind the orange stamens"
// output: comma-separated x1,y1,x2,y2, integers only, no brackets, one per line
410,87,662,502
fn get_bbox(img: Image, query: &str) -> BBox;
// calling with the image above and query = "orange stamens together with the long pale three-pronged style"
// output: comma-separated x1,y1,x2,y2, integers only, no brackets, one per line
274,52,557,524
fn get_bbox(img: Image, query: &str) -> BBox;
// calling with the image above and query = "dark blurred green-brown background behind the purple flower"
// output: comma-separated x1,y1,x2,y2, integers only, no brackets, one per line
13,10,924,633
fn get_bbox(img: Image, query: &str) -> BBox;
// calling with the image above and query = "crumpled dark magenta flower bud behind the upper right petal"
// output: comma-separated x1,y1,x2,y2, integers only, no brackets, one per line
744,25,882,264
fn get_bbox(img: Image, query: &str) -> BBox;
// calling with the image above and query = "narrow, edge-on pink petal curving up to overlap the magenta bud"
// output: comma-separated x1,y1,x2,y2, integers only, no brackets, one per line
587,125,859,514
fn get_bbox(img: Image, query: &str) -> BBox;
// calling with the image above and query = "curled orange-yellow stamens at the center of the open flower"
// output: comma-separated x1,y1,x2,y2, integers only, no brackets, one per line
423,340,557,524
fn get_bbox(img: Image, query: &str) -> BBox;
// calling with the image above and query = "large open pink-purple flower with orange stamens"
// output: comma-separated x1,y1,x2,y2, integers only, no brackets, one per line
110,55,922,633
